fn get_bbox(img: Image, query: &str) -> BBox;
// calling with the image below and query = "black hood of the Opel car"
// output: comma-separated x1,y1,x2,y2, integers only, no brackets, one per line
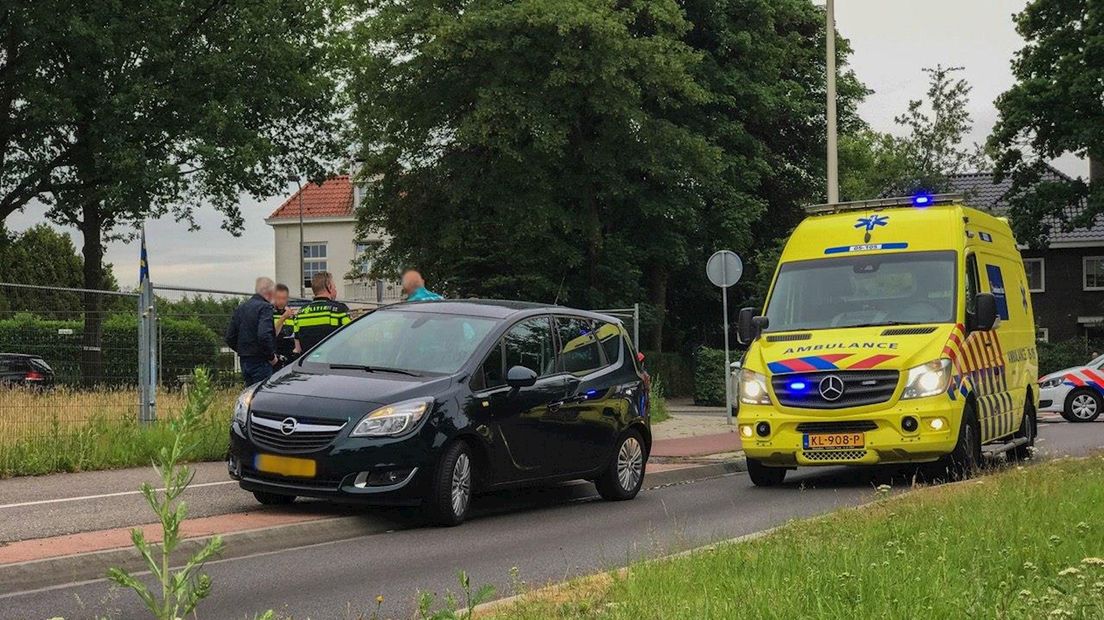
251,368,453,420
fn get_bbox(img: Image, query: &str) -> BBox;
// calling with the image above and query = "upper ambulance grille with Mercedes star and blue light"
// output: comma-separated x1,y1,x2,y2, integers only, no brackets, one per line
771,371,900,409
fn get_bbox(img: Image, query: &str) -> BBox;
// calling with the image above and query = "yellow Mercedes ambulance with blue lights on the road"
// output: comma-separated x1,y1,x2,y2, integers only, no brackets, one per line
737,195,1038,487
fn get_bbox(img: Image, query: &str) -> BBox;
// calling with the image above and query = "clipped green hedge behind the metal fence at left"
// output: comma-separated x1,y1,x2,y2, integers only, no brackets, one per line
0,313,222,386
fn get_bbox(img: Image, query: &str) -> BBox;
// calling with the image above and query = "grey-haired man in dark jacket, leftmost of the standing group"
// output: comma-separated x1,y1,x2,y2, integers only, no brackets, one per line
226,277,278,386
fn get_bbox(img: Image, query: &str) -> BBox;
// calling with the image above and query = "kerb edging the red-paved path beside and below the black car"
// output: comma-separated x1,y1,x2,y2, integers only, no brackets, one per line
0,458,747,598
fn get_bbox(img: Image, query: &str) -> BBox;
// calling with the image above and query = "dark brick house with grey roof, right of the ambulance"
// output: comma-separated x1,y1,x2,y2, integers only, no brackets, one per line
951,169,1104,342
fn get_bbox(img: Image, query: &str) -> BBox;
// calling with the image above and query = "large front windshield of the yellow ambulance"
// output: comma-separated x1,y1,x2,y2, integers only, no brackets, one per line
766,252,955,332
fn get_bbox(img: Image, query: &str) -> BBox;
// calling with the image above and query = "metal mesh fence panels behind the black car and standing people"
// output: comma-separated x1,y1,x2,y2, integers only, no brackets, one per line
0,282,639,441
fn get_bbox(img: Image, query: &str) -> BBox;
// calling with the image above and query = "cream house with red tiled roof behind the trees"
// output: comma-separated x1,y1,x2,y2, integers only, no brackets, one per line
265,174,400,302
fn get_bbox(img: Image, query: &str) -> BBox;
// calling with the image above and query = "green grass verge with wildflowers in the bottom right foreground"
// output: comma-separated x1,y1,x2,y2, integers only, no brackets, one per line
493,457,1104,620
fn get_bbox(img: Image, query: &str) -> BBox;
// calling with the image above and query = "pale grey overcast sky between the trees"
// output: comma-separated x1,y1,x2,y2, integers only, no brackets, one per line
7,0,1086,290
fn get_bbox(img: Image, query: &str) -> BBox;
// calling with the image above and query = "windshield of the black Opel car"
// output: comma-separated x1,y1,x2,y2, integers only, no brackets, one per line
305,310,497,374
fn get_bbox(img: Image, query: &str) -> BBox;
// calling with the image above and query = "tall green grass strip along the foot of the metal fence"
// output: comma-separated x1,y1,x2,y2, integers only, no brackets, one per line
0,389,238,478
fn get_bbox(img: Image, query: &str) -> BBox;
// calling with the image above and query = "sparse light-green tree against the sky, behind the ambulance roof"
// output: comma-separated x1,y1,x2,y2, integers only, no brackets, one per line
840,65,988,200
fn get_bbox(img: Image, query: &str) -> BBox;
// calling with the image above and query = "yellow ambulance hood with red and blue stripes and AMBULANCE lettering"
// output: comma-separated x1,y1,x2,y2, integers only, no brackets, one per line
744,324,962,374
